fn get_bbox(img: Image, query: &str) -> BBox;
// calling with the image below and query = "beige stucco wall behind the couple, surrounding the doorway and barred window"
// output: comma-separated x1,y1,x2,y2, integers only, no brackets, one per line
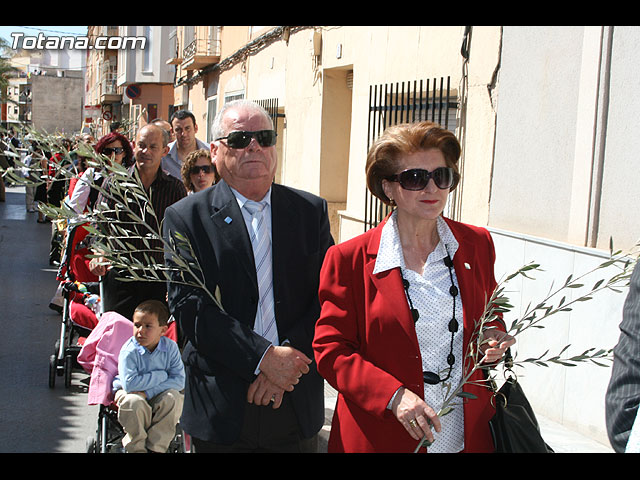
179,26,500,241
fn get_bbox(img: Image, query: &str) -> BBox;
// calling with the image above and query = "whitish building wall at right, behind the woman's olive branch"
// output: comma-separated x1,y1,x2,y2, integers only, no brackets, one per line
487,26,640,444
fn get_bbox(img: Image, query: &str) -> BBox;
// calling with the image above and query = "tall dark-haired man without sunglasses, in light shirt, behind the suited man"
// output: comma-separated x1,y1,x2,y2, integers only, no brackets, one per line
162,110,209,179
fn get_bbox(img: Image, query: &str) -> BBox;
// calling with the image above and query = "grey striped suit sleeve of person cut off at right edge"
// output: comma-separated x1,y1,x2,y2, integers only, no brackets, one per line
605,265,640,452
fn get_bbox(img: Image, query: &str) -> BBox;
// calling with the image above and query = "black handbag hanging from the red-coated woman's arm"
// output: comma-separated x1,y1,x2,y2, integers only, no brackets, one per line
489,352,554,453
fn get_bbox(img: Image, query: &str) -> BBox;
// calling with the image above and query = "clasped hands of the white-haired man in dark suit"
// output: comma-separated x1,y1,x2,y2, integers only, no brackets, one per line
260,346,311,392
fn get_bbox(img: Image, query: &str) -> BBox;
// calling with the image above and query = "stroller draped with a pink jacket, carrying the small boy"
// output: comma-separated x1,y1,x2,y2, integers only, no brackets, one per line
78,312,190,453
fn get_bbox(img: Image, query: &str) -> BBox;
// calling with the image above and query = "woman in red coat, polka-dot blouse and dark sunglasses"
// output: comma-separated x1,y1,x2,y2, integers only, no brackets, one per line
313,122,515,453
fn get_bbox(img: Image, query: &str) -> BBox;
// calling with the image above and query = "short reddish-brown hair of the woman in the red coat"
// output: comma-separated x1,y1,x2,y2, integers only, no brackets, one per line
365,122,461,205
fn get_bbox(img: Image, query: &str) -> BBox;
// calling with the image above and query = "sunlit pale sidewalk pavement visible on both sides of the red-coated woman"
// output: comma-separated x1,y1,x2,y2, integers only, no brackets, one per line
319,382,614,453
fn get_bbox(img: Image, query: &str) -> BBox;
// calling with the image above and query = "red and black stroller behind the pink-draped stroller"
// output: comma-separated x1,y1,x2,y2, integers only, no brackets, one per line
49,224,100,388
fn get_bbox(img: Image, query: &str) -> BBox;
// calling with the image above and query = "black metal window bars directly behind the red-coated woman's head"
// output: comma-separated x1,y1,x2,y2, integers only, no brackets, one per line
364,77,458,231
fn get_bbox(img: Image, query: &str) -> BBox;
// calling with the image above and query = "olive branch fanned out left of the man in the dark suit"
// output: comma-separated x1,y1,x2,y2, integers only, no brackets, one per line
3,125,223,310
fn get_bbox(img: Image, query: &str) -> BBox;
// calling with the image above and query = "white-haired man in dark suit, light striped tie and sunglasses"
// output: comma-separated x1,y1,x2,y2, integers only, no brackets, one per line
164,101,333,452
